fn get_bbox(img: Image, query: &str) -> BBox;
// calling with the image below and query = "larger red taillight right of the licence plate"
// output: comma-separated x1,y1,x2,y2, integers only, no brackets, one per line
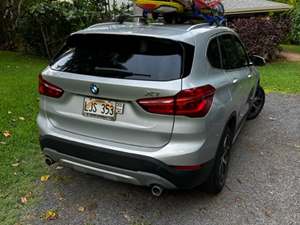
137,85,215,117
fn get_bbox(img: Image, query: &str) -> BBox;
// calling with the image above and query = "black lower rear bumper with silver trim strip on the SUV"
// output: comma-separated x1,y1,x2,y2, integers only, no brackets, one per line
40,136,213,189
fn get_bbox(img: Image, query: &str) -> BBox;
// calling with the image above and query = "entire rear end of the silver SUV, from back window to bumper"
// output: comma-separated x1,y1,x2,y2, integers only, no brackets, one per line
38,24,232,189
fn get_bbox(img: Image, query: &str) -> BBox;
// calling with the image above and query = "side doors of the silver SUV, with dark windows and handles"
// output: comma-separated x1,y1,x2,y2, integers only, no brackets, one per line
219,34,253,122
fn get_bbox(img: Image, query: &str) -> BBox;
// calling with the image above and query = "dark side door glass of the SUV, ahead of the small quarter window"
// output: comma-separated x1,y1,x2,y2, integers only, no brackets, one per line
219,34,249,69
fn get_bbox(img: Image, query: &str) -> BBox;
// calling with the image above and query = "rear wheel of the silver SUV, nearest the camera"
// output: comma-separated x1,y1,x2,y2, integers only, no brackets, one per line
204,126,233,194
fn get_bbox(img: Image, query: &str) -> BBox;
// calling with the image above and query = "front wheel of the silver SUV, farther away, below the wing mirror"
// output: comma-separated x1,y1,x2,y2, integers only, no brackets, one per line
247,85,266,120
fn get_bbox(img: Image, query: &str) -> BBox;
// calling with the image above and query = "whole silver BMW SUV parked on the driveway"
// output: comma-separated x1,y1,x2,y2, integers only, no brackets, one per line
37,23,265,195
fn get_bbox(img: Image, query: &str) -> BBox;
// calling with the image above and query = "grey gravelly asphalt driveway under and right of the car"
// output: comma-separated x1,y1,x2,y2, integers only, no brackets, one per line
26,94,300,225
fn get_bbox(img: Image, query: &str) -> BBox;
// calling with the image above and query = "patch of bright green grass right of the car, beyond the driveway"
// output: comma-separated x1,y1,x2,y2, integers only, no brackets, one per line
259,62,300,93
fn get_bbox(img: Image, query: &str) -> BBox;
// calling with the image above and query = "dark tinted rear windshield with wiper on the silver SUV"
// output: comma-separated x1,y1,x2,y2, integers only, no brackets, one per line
51,34,193,81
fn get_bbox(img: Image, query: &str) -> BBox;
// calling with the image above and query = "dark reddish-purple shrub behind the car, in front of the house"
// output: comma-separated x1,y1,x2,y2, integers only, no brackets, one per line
229,16,290,60
